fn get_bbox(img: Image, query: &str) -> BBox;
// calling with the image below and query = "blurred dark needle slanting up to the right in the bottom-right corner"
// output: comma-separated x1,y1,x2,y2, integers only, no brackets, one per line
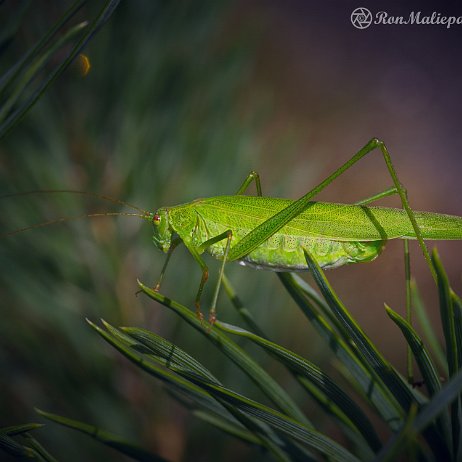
376,371,462,461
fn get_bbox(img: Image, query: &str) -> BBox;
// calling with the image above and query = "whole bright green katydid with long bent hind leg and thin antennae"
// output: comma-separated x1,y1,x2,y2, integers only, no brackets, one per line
2,138,462,323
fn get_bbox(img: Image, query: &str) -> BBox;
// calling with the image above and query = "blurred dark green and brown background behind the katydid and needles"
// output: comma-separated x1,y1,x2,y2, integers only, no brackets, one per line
0,0,462,461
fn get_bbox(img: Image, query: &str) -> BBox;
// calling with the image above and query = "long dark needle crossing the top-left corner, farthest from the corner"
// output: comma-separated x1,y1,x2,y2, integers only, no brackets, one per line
0,0,120,139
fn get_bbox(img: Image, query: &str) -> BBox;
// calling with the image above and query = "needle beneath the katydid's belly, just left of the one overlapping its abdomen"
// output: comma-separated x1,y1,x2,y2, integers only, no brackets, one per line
278,273,404,430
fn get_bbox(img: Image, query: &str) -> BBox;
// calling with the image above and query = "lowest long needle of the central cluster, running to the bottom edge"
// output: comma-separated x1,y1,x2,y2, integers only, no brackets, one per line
87,320,287,462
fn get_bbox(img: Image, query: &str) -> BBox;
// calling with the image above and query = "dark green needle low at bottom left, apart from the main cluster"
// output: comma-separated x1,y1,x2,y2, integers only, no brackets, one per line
36,409,166,462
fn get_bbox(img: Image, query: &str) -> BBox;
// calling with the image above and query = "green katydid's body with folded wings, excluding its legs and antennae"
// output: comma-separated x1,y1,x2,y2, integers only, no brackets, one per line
162,196,462,271
